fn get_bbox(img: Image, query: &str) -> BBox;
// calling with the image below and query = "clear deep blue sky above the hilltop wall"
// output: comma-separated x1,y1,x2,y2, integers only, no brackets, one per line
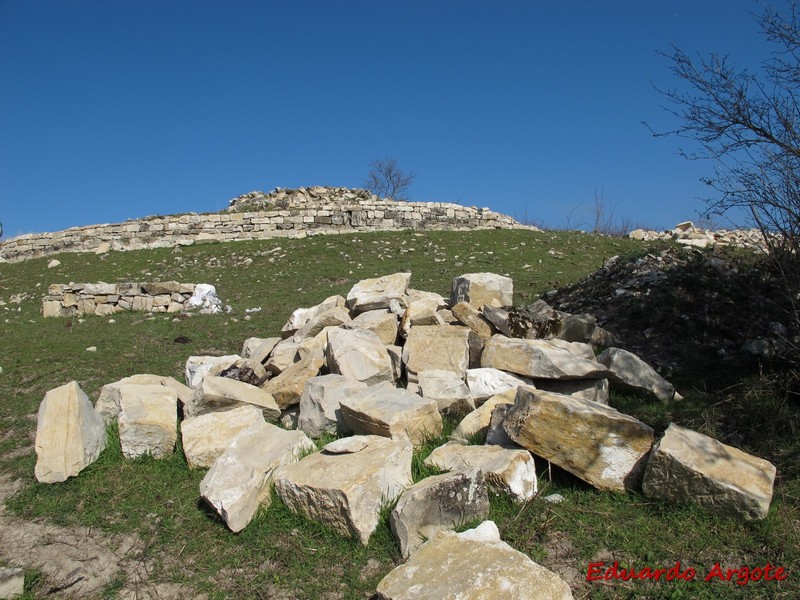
0,0,785,237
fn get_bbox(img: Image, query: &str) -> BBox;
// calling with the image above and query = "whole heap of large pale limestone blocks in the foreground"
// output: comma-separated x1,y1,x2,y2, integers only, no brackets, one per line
31,273,775,598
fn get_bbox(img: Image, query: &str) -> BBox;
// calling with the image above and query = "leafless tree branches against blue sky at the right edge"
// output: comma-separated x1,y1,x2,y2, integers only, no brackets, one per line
654,3,800,254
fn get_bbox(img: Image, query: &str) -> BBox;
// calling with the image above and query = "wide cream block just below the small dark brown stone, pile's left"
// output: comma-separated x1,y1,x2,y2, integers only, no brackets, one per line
191,375,281,421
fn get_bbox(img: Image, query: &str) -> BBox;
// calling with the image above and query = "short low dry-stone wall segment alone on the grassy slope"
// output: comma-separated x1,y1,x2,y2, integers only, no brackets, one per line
42,281,195,317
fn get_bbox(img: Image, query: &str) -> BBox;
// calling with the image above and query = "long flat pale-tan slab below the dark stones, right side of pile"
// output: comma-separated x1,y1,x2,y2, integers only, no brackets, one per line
481,334,607,379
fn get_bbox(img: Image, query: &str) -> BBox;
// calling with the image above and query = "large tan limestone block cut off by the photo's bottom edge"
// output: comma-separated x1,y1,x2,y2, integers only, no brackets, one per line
376,521,572,600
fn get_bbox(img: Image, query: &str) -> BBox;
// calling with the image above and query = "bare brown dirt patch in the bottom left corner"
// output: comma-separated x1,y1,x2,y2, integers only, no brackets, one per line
0,474,203,599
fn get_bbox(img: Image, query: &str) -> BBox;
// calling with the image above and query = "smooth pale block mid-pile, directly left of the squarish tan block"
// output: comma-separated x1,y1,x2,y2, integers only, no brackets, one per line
327,328,394,385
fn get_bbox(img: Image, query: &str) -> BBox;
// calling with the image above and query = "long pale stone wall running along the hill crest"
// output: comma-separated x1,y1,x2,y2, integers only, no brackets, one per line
0,188,525,262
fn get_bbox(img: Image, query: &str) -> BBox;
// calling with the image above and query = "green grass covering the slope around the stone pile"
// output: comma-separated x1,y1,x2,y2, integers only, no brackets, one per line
0,230,800,598
